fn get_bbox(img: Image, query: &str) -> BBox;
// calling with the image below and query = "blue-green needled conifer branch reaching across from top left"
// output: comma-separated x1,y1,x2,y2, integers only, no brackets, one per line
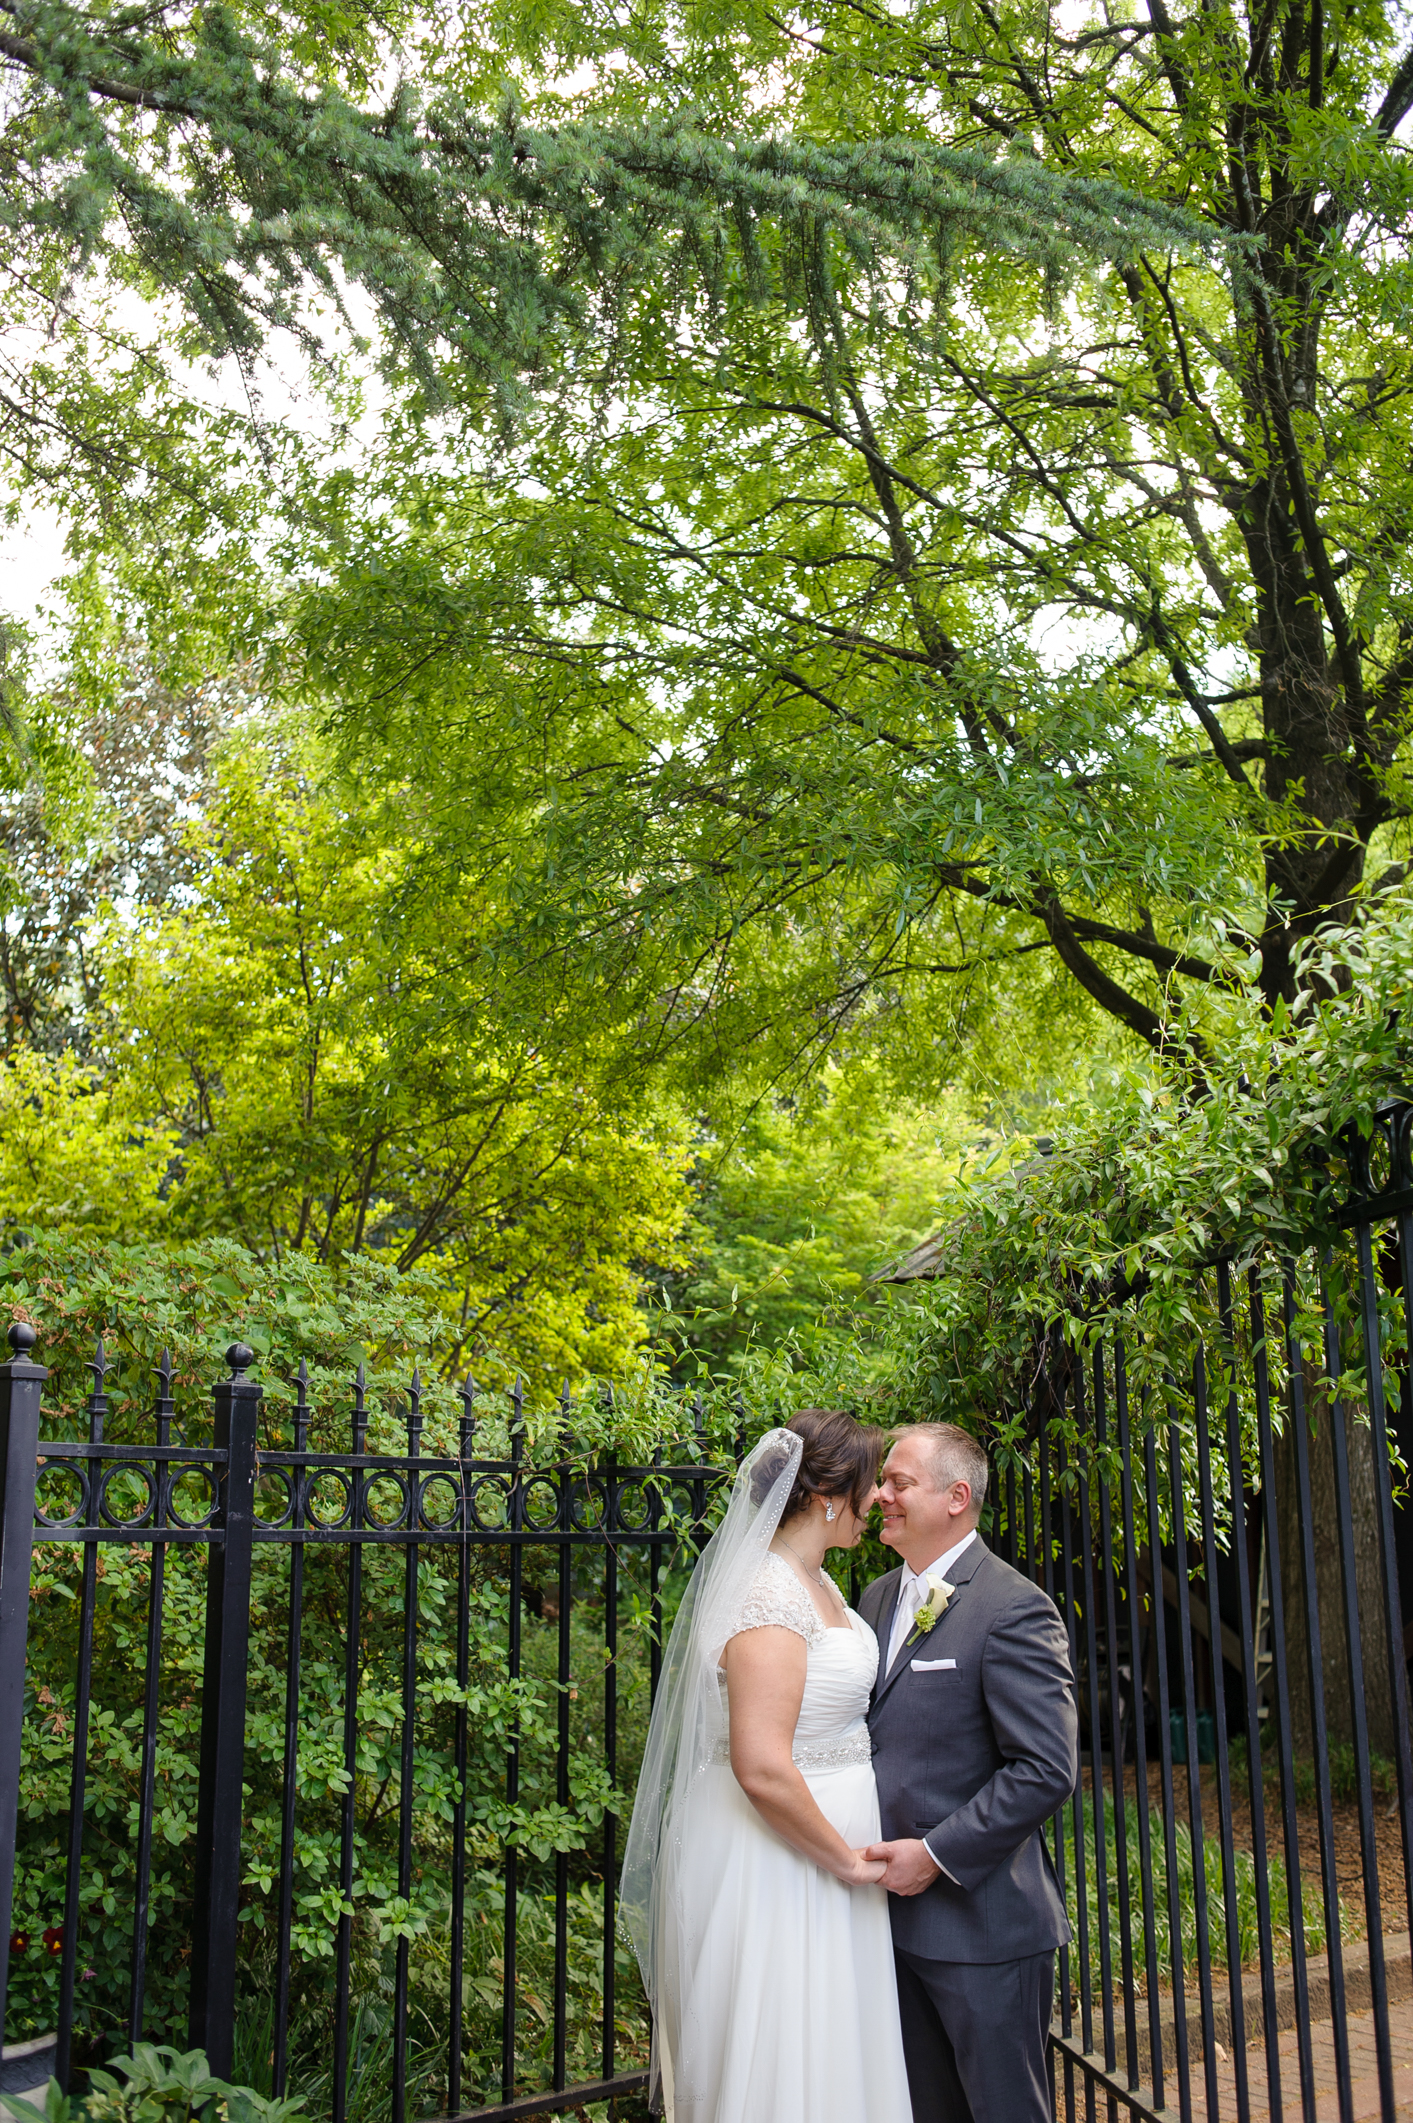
0,0,1186,581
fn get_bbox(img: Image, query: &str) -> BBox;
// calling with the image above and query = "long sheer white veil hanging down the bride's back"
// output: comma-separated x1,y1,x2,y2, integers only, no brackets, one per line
620,1431,804,2093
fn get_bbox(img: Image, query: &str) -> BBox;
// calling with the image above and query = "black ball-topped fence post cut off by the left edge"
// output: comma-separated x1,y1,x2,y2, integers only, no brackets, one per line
0,1321,49,2038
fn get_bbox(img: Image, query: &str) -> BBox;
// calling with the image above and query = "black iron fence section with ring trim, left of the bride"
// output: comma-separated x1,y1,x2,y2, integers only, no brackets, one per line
0,1325,719,2123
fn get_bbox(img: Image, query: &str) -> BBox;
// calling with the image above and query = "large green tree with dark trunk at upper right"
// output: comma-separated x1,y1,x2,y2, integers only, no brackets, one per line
271,0,1413,1076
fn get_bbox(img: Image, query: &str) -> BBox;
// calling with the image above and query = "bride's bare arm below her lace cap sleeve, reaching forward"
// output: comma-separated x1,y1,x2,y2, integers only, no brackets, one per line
726,1628,885,1887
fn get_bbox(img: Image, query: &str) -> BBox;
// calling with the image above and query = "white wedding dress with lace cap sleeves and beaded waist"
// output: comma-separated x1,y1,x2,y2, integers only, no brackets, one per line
656,1552,912,2123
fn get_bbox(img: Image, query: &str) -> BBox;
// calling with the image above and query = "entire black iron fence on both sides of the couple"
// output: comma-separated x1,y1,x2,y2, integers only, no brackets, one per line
0,1106,1413,2123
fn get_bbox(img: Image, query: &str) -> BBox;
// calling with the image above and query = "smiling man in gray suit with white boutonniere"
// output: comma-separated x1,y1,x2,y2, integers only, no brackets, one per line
859,1422,1080,2123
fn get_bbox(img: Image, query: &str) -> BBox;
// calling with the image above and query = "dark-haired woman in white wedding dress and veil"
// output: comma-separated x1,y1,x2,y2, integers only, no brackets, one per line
622,1408,912,2123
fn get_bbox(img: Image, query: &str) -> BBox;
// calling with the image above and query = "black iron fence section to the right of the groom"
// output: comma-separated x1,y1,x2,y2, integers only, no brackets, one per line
995,1106,1413,2123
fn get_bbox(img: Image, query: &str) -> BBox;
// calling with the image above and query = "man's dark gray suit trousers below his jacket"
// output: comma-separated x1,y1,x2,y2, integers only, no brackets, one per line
897,1949,1054,2123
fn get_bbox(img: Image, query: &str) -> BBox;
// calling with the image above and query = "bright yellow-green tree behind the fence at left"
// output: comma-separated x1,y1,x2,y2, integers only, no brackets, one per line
0,713,687,1393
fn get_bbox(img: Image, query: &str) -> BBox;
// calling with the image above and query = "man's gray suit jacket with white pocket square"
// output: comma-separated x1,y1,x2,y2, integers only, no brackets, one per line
859,1535,1080,1962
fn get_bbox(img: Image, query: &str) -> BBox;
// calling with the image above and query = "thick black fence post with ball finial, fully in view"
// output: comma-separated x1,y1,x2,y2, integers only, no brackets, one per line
187,1342,261,2078
